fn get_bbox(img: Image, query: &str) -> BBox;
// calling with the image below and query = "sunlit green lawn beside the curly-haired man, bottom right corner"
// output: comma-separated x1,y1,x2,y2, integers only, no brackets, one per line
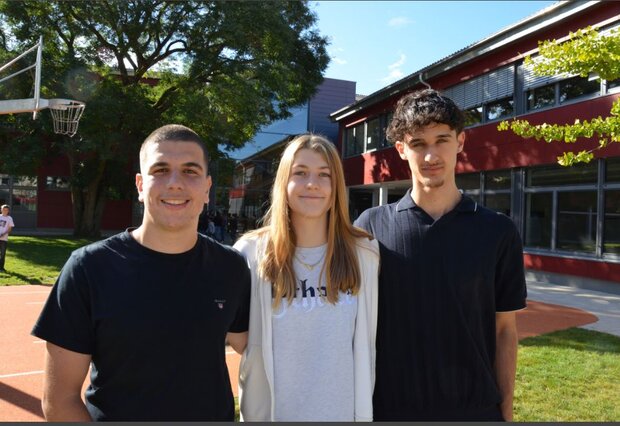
515,328,620,422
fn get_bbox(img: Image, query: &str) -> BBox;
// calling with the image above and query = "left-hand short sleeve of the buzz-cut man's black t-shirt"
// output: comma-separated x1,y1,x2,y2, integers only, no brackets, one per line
32,252,94,354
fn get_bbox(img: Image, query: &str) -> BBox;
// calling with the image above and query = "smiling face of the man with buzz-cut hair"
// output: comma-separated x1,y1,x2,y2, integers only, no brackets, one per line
136,141,211,231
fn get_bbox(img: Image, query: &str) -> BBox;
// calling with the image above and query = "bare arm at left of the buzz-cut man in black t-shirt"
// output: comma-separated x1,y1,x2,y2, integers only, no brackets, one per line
41,342,93,422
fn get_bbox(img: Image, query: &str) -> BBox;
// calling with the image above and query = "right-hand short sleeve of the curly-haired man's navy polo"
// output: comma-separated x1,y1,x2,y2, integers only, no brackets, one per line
495,222,527,312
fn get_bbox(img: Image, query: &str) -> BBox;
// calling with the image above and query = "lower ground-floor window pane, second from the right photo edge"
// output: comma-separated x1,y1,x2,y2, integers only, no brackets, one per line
557,191,596,253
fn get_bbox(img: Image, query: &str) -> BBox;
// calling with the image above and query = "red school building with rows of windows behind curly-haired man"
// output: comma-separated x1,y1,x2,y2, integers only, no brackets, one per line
331,1,620,286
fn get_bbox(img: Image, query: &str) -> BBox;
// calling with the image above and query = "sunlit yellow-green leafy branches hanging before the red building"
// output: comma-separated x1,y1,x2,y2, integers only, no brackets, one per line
498,27,620,166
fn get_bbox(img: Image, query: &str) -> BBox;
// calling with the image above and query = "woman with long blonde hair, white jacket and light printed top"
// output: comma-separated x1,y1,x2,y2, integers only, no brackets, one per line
234,134,379,422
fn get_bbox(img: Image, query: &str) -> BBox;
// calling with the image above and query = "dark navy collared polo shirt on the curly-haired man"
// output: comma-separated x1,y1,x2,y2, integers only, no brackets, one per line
355,190,526,420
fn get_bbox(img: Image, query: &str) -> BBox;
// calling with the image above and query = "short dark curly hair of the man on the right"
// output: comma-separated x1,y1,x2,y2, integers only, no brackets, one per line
385,89,465,143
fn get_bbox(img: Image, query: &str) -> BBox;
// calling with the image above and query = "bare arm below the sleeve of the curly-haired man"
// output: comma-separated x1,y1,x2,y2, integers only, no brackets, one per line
495,312,518,421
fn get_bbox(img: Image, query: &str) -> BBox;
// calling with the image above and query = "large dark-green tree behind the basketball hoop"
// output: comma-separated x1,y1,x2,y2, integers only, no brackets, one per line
0,0,329,236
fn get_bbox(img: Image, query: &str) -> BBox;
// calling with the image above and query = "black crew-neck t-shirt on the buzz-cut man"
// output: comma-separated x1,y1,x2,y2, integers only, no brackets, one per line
32,231,250,421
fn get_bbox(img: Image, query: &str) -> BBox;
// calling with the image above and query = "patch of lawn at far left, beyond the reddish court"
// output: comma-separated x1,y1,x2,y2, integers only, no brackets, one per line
0,236,92,286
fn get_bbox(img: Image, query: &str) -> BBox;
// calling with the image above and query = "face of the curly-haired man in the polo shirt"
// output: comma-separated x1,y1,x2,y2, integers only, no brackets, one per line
394,124,465,190
